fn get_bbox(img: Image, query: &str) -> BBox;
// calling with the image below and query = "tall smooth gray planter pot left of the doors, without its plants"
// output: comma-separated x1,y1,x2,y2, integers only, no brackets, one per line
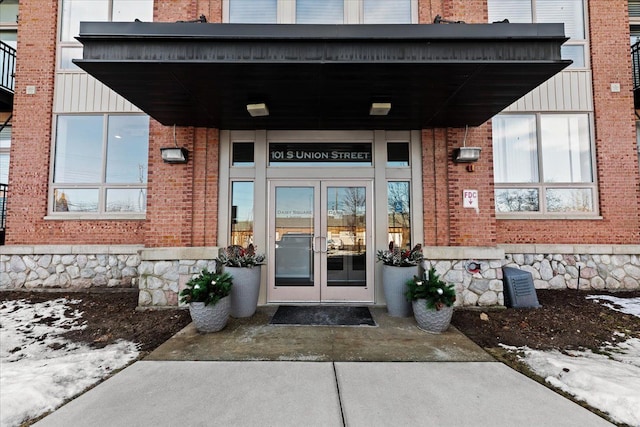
224,266,260,318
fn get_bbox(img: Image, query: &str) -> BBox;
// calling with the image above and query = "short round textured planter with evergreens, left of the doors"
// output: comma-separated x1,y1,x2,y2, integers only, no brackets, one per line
180,268,233,332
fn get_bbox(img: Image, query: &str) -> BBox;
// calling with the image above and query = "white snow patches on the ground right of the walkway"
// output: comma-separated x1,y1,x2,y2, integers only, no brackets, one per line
505,295,640,427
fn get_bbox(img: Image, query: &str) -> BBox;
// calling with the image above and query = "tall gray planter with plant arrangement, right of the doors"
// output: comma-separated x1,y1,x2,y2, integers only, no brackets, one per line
377,241,423,317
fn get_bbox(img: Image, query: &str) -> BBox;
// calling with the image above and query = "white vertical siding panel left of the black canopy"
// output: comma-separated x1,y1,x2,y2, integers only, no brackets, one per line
53,73,140,113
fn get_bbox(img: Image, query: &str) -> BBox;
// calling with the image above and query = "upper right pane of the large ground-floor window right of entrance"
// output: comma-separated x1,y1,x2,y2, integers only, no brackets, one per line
540,114,593,182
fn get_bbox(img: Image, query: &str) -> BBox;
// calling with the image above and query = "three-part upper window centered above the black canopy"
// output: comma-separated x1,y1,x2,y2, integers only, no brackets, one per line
224,0,417,24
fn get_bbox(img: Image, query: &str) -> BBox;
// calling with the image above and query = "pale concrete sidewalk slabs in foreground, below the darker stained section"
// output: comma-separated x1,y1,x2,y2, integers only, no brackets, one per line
36,361,612,427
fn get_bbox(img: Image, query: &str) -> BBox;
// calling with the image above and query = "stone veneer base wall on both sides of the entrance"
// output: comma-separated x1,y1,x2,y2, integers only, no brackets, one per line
0,245,640,308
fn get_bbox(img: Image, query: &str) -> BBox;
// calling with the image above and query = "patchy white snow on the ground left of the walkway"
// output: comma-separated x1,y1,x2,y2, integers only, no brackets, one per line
0,298,139,427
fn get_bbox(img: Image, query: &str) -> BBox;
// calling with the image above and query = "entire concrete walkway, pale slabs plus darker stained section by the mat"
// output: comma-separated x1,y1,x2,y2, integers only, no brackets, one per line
35,307,612,427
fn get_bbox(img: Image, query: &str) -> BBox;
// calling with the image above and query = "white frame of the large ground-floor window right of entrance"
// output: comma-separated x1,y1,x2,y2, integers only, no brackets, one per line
494,111,601,219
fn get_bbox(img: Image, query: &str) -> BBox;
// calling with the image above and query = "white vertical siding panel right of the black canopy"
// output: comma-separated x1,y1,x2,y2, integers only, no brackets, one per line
504,70,593,112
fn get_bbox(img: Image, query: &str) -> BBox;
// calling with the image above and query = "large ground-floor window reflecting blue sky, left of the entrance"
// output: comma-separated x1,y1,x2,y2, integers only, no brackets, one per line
51,114,149,215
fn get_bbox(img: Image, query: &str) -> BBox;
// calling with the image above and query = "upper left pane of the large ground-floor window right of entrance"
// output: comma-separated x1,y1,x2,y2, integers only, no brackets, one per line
493,115,539,182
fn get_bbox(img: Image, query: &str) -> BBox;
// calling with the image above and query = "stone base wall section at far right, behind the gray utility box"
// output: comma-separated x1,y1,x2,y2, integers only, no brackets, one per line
501,245,640,291
